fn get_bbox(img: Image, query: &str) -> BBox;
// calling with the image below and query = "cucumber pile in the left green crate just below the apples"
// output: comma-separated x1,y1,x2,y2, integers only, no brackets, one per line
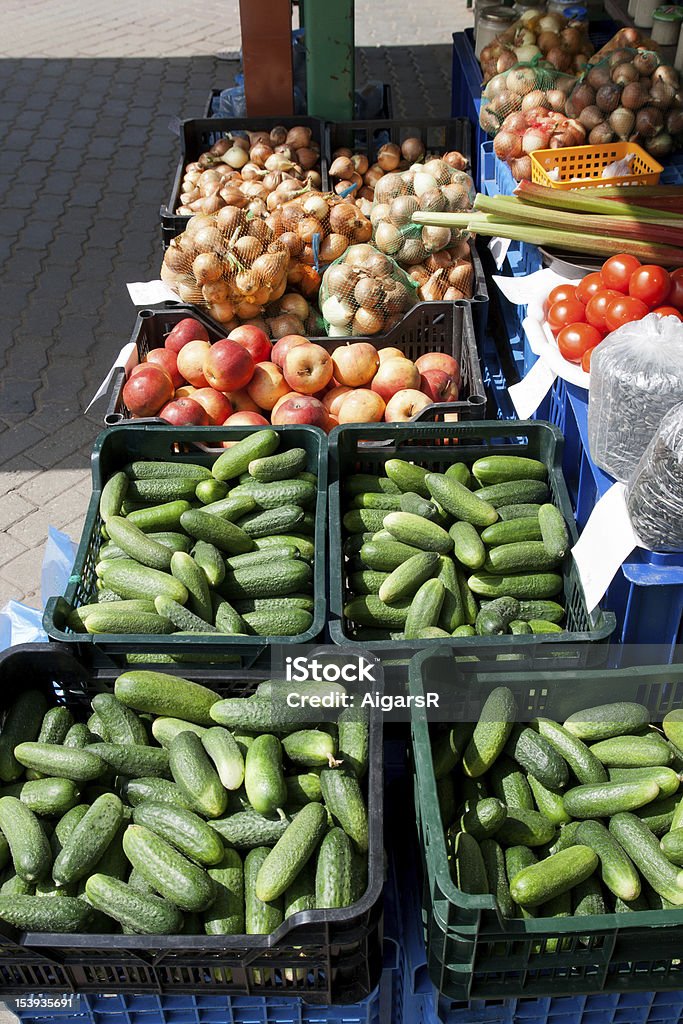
69,429,317,636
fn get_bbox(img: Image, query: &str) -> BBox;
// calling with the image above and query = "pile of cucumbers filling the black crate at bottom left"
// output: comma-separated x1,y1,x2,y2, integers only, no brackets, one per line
0,671,369,935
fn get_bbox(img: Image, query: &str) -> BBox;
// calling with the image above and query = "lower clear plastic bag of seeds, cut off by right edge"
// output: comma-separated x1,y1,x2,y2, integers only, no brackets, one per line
626,402,683,551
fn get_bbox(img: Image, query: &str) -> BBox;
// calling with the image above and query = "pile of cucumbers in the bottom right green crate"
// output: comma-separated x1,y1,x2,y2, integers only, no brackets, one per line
431,687,683,918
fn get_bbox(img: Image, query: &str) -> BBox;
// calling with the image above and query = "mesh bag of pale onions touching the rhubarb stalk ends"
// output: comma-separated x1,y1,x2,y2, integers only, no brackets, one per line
370,158,476,266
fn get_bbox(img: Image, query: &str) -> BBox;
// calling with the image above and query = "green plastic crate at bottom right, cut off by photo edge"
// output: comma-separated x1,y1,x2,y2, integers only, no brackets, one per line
410,648,683,999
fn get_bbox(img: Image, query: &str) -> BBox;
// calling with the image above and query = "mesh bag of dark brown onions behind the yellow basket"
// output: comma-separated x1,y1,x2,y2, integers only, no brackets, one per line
565,47,683,157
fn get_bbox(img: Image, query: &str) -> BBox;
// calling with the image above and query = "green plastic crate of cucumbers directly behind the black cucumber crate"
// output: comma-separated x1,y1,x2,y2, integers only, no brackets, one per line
43,424,328,663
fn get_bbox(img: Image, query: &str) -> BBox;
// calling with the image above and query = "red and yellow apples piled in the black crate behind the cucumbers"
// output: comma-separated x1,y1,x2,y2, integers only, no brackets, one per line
123,317,461,431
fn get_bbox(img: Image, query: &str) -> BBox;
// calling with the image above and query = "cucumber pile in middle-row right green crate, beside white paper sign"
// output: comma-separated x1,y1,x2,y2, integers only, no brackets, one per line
343,456,570,640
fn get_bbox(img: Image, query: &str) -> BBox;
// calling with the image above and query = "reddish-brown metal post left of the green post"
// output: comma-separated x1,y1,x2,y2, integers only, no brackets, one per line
240,0,294,118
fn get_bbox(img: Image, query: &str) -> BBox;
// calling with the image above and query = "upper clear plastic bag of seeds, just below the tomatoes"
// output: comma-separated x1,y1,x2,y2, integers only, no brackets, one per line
588,313,683,482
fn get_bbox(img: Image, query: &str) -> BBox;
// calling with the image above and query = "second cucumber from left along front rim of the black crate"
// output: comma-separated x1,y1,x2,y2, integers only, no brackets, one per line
85,872,182,935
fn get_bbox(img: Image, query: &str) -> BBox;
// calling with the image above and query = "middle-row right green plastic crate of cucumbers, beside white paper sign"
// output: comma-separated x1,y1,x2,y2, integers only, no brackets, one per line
330,420,616,656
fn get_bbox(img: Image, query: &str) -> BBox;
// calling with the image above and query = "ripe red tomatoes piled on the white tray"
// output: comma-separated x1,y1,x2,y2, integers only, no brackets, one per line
545,254,683,373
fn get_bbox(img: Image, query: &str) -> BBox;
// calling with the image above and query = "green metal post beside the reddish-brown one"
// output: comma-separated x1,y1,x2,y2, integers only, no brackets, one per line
300,0,354,121
